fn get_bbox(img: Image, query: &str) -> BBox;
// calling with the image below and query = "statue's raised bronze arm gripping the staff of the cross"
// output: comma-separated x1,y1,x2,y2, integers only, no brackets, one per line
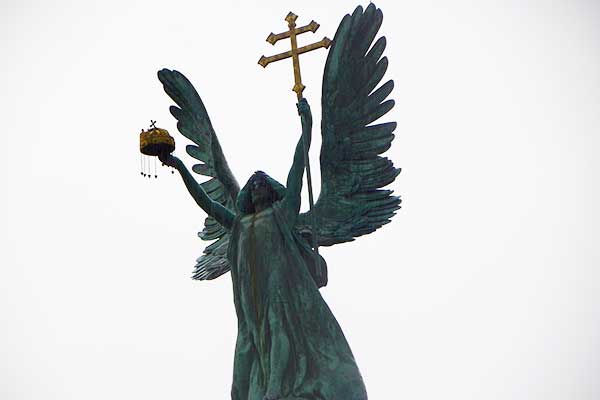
284,99,312,217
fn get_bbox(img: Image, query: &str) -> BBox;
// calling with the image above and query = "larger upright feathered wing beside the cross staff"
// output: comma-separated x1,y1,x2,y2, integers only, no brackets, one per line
297,3,400,246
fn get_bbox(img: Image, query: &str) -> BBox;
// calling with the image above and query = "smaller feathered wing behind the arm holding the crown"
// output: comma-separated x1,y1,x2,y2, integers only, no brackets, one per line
158,69,240,280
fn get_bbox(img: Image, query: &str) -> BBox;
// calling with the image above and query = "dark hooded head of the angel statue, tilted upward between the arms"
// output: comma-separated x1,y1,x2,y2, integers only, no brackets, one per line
237,171,285,214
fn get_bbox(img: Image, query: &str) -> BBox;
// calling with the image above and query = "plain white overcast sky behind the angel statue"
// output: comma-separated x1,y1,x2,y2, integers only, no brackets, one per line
0,0,600,400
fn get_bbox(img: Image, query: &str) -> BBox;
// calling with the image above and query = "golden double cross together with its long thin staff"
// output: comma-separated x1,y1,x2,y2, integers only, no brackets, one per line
258,12,331,274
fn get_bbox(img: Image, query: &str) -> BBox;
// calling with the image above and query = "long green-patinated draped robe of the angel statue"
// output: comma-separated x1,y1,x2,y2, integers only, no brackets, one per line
228,201,367,400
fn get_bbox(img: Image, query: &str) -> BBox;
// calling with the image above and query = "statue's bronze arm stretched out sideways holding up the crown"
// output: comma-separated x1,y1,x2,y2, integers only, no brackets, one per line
158,154,235,229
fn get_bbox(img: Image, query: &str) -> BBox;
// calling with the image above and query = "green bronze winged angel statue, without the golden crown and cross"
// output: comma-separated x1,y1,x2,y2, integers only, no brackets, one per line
158,4,400,400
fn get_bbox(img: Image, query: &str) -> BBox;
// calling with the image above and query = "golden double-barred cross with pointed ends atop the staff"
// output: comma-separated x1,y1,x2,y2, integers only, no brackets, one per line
258,12,331,100
